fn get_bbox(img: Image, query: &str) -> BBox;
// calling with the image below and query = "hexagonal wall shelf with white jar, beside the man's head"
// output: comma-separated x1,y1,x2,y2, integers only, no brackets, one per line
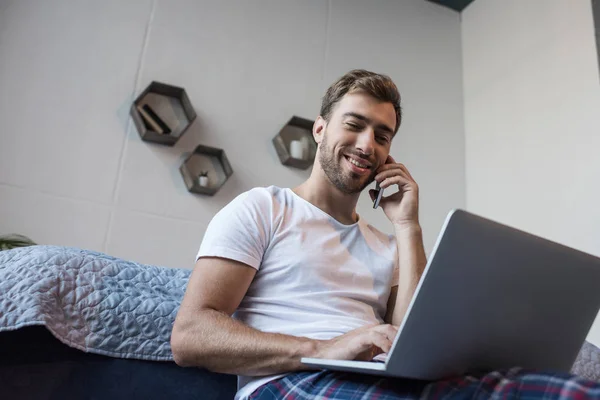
273,116,317,169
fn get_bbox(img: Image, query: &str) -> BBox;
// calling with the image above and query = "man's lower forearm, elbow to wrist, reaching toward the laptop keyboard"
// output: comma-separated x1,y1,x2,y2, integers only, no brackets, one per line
172,310,318,376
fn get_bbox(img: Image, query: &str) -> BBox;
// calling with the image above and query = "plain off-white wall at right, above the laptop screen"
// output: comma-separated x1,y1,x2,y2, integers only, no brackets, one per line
462,0,600,345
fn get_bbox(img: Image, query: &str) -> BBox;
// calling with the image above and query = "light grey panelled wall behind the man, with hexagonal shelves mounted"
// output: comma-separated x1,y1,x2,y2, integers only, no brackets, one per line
0,0,465,268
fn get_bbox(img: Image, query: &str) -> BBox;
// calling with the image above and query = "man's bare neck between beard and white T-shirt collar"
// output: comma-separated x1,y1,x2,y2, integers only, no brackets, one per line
293,173,360,225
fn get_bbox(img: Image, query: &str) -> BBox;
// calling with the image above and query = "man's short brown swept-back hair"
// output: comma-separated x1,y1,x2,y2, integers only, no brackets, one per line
321,69,402,133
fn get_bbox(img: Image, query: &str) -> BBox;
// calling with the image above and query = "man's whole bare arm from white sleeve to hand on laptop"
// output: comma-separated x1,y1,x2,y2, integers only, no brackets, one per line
171,258,395,376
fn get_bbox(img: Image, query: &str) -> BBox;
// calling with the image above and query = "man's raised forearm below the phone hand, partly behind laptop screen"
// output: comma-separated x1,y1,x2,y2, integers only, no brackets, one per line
392,224,427,326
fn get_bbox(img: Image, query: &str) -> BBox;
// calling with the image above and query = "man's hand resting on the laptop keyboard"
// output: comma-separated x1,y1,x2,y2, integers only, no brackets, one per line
315,325,398,361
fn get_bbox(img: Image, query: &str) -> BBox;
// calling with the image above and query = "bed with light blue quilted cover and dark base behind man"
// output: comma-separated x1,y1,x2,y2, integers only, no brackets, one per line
0,246,600,399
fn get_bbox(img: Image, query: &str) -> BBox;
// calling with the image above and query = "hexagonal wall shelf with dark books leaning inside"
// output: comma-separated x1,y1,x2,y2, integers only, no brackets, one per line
130,81,196,146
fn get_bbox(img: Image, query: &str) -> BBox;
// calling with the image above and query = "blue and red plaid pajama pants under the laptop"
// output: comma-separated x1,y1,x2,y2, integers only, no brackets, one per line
250,368,600,400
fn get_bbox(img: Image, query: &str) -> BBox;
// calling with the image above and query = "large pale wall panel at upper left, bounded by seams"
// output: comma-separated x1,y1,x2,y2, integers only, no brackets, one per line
0,0,150,204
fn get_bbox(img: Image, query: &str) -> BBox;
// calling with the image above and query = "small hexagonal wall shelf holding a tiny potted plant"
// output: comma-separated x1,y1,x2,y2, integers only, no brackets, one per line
179,145,233,196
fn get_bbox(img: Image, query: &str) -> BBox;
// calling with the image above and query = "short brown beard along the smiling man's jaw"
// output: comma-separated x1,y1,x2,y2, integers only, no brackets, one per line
319,131,377,194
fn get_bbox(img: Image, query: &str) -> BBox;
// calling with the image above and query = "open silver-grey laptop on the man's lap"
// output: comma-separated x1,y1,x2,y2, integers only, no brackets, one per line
301,210,600,380
